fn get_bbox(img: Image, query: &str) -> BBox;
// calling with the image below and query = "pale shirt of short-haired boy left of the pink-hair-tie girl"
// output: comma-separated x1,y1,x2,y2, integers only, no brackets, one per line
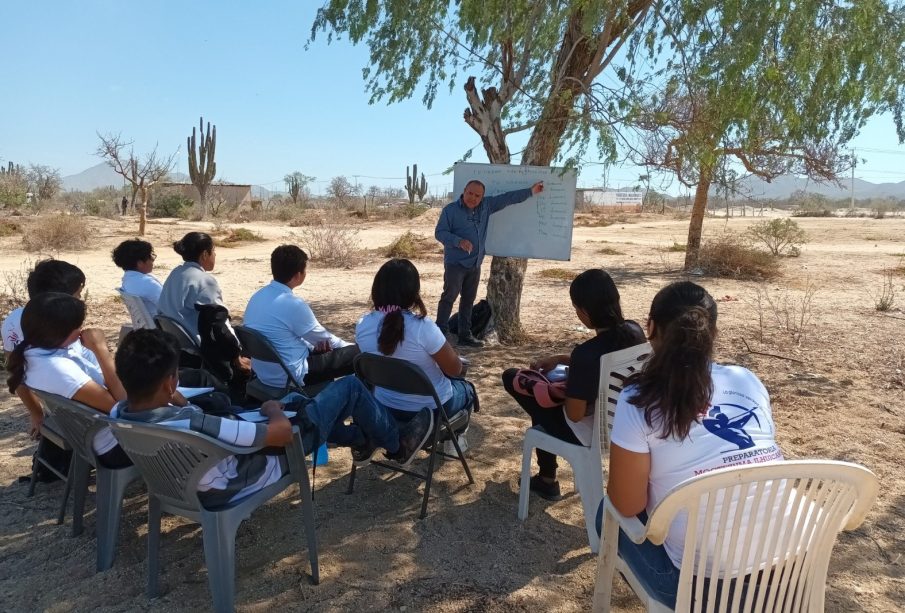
242,280,351,387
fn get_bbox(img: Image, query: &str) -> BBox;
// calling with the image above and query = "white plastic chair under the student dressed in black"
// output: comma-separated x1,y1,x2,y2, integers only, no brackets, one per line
518,343,651,553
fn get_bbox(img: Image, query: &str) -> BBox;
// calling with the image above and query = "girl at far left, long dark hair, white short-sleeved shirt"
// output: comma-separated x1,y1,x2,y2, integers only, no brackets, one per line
6,292,131,468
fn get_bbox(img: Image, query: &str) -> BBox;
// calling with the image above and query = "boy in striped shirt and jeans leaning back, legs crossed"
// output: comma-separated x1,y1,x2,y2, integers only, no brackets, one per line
115,329,431,507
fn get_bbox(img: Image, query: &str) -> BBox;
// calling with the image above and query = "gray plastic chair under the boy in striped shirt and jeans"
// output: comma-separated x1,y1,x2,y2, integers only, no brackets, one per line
112,420,320,611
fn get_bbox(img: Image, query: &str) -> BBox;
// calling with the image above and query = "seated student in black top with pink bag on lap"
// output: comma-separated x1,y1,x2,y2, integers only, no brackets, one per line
503,268,644,500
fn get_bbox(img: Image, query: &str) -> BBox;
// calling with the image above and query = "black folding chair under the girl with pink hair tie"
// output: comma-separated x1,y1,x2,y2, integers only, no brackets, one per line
347,353,474,519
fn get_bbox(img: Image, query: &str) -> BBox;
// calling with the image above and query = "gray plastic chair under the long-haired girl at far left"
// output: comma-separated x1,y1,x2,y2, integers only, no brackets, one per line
32,390,139,572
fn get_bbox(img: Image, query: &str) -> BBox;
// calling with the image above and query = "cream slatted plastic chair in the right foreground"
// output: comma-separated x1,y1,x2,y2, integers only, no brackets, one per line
593,460,879,613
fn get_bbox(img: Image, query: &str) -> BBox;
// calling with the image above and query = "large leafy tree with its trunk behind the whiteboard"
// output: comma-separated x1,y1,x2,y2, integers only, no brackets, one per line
312,0,902,341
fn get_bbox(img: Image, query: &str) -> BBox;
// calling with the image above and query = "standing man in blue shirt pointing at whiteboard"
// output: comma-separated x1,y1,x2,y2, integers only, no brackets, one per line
434,180,544,347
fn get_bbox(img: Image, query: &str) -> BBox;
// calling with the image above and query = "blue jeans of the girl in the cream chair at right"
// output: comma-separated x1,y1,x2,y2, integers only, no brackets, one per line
597,500,679,608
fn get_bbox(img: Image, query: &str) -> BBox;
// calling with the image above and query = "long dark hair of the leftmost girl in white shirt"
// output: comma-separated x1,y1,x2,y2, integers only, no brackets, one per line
6,292,85,394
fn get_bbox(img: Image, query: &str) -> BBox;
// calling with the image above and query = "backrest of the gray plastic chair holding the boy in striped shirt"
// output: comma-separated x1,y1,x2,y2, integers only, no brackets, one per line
110,420,255,512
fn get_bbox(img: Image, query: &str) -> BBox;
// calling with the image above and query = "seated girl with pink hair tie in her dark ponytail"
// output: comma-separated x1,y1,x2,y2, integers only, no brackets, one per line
355,259,475,444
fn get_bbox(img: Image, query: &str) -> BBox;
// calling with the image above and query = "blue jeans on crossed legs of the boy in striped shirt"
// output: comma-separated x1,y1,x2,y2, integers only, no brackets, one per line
283,377,399,453
